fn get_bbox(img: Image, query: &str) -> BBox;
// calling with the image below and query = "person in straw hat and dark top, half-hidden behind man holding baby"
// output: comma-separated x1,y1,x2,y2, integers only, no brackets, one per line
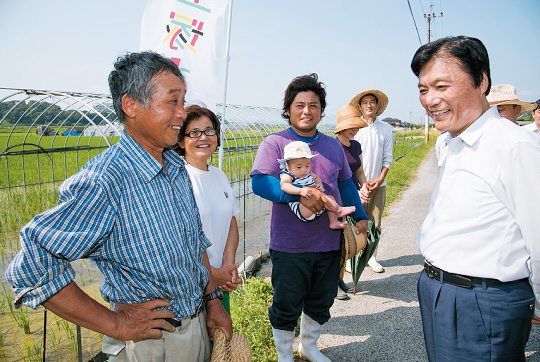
334,105,369,300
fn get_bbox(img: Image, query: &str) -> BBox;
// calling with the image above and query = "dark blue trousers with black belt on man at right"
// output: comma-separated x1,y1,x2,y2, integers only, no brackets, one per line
418,271,534,362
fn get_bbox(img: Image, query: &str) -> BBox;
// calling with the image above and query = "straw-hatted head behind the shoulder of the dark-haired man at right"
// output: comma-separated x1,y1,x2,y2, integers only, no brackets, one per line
487,84,535,123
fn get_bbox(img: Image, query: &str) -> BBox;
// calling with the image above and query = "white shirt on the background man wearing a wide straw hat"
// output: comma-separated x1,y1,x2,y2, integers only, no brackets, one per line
354,117,394,186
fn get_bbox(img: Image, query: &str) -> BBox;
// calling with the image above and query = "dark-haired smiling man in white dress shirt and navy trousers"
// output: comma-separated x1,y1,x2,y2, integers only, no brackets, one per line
411,36,540,362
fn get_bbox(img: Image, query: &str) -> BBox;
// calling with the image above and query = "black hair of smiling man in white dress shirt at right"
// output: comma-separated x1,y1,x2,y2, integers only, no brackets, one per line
411,35,491,96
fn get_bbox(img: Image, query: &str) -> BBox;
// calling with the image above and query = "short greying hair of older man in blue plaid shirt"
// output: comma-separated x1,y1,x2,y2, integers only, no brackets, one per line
109,51,185,123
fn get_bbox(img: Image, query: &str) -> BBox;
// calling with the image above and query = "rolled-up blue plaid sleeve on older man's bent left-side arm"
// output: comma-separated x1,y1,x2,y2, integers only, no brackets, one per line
6,173,116,309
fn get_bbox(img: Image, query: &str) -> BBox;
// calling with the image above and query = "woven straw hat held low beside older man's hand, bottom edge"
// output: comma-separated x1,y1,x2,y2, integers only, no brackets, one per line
210,328,251,362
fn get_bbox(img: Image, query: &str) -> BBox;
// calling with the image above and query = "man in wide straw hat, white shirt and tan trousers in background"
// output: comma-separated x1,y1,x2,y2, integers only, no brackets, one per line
349,89,394,273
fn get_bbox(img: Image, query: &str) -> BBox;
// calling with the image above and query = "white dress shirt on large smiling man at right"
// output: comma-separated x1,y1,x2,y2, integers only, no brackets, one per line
416,107,540,316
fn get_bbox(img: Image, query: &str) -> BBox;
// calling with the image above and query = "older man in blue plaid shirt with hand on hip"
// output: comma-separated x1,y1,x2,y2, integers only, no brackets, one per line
6,52,232,361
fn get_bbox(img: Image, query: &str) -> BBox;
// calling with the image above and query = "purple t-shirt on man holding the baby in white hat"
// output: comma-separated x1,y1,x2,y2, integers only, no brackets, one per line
251,129,351,253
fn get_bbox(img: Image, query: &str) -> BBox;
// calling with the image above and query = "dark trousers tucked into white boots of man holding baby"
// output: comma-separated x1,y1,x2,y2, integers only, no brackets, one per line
268,249,341,331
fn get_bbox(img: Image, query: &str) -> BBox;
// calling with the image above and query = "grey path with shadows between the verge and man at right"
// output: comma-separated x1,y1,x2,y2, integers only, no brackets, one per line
319,151,540,362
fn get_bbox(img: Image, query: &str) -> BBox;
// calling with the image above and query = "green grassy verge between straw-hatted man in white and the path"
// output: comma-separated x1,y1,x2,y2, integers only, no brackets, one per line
383,140,435,215
